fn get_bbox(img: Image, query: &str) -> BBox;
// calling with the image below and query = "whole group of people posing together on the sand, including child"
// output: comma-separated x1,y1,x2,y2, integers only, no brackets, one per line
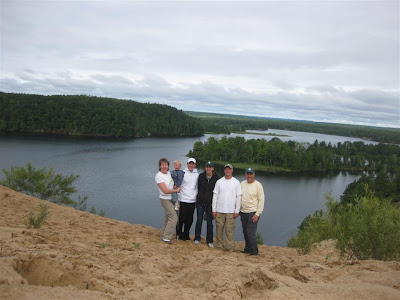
155,157,264,255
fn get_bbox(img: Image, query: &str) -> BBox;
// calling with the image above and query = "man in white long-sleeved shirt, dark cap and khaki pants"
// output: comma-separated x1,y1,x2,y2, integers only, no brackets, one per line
212,164,242,251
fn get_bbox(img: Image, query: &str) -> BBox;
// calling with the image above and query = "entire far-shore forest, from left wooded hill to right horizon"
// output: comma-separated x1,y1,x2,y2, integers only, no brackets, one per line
0,92,400,144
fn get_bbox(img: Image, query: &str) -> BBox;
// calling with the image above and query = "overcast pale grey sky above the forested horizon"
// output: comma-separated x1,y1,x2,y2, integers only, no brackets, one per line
0,0,400,127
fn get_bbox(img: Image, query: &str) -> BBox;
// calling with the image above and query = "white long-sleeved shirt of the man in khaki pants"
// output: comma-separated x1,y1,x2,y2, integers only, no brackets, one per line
212,177,242,214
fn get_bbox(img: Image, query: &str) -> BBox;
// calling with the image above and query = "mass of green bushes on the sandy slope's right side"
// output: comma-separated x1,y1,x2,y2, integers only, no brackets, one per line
288,186,400,260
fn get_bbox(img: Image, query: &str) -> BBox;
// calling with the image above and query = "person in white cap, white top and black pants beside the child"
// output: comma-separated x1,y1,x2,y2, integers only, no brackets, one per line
176,157,199,241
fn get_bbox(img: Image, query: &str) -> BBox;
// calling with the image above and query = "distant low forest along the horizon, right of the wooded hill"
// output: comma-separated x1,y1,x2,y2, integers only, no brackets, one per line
186,111,400,144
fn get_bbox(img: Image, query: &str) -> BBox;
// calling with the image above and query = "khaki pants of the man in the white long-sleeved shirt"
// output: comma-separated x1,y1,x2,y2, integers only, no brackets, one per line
215,212,236,251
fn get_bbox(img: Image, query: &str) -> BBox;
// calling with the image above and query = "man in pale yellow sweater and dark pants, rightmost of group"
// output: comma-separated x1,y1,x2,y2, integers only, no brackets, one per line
240,168,264,255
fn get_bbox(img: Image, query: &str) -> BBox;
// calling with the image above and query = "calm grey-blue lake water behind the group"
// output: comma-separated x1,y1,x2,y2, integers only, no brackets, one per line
0,130,366,246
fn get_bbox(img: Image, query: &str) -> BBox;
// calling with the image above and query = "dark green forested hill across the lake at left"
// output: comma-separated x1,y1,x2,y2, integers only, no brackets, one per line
0,92,204,137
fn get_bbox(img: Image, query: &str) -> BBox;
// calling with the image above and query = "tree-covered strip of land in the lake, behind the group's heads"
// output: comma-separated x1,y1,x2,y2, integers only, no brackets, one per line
188,137,400,171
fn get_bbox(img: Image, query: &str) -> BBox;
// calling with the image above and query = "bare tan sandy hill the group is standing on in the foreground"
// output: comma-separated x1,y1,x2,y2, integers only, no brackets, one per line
0,186,400,299
